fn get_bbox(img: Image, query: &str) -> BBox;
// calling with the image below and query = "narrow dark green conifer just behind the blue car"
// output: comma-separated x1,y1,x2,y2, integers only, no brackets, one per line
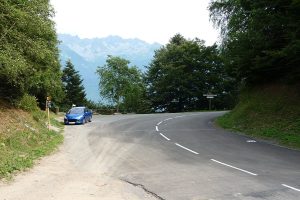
62,60,87,107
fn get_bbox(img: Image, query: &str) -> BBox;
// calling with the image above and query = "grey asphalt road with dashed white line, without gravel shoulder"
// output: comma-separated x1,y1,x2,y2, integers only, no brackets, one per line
82,112,300,200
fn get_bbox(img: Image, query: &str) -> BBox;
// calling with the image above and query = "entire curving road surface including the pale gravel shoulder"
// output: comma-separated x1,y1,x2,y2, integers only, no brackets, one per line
0,112,300,200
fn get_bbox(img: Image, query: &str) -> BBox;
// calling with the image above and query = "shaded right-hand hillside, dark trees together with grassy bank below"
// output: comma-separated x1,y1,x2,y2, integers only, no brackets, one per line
209,0,300,148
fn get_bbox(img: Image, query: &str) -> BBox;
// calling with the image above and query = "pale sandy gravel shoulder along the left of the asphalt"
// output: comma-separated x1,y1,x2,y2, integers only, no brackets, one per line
0,116,156,200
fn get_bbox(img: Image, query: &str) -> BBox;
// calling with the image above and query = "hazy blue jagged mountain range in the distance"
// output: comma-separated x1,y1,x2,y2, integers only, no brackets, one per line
58,34,162,102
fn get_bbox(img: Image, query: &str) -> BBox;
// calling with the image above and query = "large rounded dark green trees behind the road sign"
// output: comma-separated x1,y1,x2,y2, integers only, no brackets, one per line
146,34,234,112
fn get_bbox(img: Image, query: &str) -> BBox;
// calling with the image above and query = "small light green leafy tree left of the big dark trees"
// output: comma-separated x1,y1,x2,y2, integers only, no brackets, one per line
97,56,145,112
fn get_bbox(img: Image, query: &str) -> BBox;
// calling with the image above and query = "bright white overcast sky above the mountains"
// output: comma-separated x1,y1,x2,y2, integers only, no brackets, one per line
51,0,218,44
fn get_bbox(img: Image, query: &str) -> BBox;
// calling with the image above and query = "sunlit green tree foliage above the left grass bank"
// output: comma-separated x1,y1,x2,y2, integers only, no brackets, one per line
0,0,62,105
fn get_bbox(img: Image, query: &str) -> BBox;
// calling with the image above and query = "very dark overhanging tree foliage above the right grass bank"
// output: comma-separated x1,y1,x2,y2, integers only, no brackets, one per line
209,0,300,85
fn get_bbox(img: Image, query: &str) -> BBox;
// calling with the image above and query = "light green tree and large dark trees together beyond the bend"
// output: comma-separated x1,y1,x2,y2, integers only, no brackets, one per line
97,34,237,113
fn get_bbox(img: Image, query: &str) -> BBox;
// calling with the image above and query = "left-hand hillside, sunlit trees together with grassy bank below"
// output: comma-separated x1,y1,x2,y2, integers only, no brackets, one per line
0,0,64,179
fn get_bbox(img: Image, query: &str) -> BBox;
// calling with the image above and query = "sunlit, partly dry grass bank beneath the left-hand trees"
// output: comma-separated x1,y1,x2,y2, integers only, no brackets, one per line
0,99,63,180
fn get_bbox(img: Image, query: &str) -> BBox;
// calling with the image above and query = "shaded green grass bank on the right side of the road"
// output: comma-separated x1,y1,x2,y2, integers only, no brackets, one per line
217,86,300,150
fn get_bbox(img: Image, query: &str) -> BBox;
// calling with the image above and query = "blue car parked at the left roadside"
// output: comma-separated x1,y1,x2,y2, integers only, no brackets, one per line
64,107,93,125
